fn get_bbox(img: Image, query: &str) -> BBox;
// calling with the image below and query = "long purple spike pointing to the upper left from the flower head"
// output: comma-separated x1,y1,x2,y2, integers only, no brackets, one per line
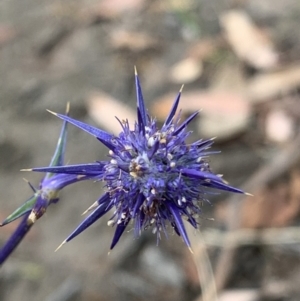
49,111,114,148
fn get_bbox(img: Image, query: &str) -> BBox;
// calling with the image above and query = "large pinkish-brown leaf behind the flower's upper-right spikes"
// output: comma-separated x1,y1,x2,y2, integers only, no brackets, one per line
151,90,251,139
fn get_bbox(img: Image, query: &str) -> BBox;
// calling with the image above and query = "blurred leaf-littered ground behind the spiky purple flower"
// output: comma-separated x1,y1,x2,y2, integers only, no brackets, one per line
0,0,300,301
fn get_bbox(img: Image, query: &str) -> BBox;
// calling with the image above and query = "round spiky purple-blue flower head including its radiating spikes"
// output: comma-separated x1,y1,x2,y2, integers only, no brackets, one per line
33,68,243,249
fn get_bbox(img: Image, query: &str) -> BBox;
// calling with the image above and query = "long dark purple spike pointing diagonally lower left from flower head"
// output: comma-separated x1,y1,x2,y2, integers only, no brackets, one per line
64,193,112,242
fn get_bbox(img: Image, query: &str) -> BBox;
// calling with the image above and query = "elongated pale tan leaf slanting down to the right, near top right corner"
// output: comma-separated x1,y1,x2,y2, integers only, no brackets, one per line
220,10,278,69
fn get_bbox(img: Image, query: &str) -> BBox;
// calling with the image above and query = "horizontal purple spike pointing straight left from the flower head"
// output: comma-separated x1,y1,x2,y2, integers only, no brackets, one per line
31,163,105,175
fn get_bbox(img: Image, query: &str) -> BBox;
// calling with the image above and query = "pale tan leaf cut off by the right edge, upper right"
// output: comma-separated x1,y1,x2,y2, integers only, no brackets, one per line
246,65,300,103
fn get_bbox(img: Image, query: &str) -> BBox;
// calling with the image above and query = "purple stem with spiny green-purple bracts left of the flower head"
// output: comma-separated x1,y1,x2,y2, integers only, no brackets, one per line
0,106,94,265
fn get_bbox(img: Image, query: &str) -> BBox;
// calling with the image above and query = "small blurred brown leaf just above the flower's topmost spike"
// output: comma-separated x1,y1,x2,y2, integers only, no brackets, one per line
110,29,159,52
